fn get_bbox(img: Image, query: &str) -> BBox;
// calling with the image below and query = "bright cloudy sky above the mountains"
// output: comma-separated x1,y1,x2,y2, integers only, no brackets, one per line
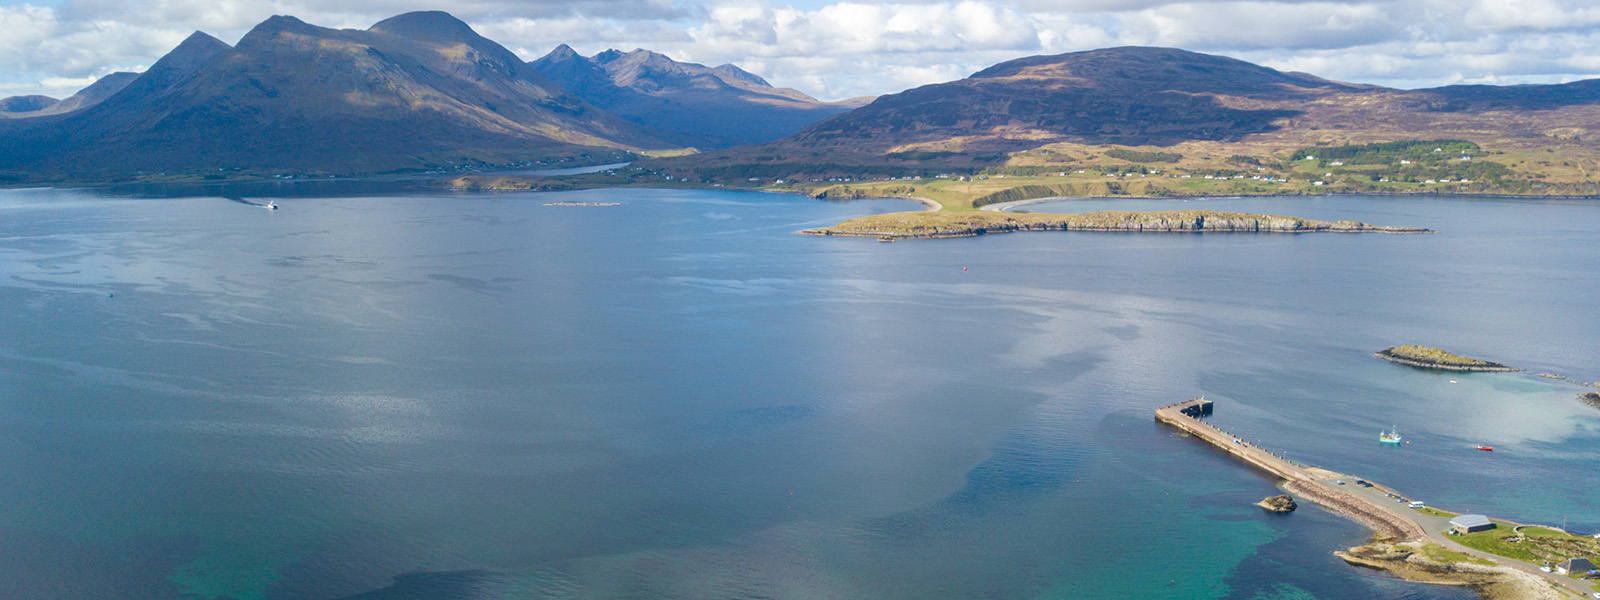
0,0,1600,99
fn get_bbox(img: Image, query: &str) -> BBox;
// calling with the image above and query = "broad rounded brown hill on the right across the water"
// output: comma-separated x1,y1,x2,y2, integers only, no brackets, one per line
659,46,1600,179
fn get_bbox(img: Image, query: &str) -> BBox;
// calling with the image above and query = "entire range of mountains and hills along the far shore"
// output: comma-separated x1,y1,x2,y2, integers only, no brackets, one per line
0,11,1600,184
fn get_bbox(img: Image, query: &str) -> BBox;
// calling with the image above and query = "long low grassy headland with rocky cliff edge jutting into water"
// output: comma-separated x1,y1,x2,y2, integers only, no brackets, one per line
802,210,1432,238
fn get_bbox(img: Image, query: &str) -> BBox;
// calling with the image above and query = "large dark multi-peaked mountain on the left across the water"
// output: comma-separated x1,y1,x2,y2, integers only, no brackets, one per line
0,13,674,182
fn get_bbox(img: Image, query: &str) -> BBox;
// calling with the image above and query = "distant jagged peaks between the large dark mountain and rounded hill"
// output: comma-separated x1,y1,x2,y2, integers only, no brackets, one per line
531,45,866,149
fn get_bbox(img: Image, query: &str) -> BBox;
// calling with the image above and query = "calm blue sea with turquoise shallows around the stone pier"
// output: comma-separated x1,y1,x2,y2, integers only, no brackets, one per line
0,187,1600,598
